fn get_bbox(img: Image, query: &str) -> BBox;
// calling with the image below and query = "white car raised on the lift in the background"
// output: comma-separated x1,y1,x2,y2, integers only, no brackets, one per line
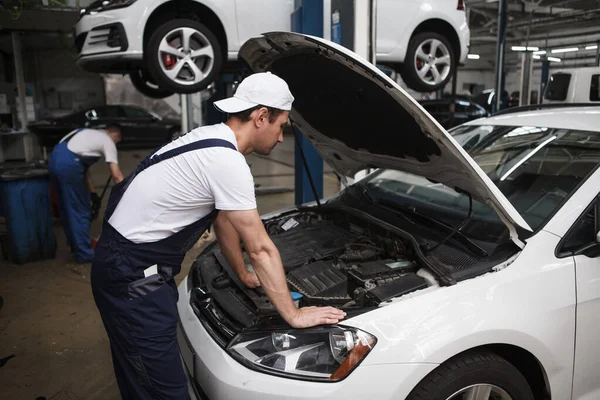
73,0,470,97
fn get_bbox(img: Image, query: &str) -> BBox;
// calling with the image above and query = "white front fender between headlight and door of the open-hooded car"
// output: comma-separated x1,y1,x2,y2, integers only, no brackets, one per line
346,232,576,399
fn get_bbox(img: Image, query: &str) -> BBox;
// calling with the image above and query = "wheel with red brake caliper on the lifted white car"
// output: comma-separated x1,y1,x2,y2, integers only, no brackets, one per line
144,19,223,93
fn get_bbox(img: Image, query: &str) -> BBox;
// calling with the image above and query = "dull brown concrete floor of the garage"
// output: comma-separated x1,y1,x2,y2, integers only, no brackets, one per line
0,136,339,400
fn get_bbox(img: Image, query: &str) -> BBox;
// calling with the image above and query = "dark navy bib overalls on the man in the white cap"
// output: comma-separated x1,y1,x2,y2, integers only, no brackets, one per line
91,139,235,399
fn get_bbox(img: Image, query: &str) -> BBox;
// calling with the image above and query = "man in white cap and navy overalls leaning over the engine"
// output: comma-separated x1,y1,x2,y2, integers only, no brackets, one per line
91,73,345,399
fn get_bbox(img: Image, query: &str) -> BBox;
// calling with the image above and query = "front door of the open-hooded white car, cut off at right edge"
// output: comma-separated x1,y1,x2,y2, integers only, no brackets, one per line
558,198,600,400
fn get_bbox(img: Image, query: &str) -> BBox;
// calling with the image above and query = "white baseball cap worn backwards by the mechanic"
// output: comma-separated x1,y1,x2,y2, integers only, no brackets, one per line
213,72,294,114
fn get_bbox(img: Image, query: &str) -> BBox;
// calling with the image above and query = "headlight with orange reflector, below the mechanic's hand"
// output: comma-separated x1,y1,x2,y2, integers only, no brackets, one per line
227,326,377,382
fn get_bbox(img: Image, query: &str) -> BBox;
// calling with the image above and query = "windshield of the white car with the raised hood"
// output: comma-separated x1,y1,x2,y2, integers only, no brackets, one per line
363,125,600,242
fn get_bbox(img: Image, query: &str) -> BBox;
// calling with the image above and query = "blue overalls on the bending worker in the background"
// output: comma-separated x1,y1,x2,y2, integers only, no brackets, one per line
48,129,100,263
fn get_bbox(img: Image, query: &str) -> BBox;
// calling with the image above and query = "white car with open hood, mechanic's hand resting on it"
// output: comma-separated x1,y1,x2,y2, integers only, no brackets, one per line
178,32,600,400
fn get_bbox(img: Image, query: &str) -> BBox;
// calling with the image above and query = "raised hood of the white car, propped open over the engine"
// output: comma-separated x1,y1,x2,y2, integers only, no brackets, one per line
239,32,531,247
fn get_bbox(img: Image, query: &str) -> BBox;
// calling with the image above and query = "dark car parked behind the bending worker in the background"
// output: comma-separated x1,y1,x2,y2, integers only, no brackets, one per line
28,105,181,148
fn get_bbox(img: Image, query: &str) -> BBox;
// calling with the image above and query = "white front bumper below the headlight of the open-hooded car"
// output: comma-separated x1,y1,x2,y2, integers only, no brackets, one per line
177,279,436,400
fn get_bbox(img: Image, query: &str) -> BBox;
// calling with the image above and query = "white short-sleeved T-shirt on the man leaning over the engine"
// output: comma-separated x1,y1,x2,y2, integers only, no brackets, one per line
109,124,256,243
